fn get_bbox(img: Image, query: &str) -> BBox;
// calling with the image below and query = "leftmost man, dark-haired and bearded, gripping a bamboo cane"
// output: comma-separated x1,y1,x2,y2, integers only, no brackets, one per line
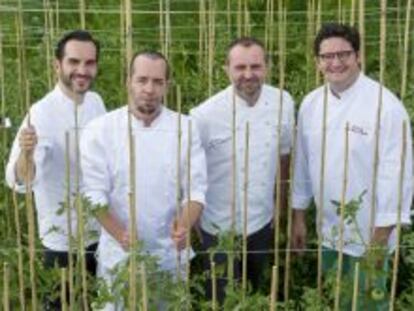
6,30,105,309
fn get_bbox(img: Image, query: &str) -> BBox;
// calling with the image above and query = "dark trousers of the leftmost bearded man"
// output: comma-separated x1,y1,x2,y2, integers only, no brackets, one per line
43,243,98,311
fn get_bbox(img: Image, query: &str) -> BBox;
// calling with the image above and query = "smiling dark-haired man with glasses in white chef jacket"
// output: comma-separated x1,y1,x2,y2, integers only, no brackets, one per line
292,24,412,310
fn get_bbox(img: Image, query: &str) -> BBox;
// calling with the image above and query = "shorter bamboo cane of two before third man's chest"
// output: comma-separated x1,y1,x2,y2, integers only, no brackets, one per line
242,122,250,300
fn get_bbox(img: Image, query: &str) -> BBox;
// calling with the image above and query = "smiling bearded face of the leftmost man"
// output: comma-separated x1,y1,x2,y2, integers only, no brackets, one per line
55,40,97,94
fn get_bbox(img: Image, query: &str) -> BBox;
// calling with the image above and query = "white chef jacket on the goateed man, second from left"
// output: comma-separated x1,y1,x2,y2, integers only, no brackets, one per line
81,107,207,270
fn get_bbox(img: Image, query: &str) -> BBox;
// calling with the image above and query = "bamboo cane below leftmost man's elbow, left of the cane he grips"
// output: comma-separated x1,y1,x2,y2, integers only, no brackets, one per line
12,189,26,311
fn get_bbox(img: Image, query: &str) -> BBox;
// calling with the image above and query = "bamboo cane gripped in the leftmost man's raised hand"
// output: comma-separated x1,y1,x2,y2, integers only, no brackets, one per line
25,80,37,310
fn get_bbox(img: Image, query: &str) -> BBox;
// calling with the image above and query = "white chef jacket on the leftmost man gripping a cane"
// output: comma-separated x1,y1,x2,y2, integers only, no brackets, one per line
6,85,105,251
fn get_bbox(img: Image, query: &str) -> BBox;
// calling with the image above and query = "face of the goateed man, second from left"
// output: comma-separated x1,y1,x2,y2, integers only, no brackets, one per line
128,55,168,115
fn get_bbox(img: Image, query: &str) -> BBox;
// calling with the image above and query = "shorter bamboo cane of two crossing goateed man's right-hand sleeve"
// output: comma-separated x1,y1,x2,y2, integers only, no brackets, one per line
185,120,193,294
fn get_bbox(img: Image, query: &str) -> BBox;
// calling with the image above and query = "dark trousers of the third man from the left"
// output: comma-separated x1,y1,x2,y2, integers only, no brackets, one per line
201,223,273,304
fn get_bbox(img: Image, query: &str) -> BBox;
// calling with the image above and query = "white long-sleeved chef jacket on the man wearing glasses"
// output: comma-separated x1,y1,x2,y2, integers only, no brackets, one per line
293,73,412,256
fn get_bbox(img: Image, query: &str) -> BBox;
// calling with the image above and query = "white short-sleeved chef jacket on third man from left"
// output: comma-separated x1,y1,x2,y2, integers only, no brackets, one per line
190,85,294,234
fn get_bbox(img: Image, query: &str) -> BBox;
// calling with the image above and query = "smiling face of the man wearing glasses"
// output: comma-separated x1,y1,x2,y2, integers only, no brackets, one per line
317,37,360,91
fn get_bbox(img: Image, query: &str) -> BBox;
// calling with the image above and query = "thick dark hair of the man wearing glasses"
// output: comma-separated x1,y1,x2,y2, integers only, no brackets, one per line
313,23,360,56
